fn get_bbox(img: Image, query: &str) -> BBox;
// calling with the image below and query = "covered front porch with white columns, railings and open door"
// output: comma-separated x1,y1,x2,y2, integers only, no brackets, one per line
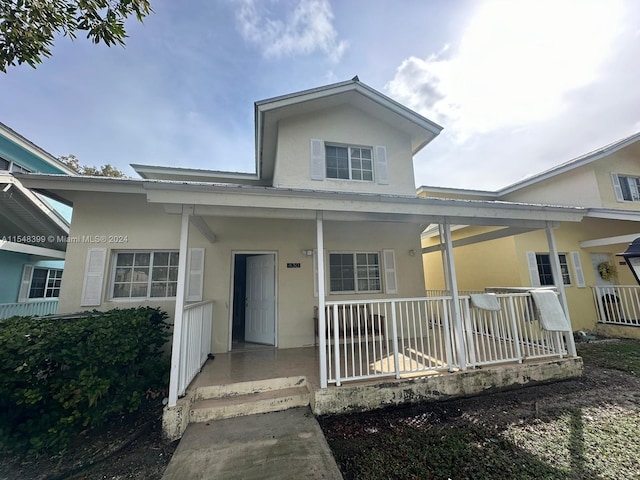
158,187,584,438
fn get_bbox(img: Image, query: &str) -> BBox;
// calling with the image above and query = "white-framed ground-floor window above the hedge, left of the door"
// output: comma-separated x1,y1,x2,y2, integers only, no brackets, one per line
112,252,178,298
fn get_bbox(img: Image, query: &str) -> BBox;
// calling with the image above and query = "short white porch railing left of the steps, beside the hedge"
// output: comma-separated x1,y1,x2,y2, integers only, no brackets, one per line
178,300,213,396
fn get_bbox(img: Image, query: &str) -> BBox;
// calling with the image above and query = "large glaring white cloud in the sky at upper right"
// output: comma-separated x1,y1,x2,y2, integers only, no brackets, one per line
386,0,623,142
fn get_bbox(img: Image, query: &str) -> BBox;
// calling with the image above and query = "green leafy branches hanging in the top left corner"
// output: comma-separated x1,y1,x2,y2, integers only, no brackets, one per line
0,0,152,72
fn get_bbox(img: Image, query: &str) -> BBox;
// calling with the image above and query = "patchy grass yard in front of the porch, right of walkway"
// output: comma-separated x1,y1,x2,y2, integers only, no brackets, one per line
321,340,640,480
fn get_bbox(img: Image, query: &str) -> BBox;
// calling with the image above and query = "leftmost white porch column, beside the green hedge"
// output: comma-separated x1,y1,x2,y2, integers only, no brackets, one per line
168,206,193,407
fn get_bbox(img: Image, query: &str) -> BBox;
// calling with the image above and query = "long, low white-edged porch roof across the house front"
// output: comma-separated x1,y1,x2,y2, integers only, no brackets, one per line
19,174,587,228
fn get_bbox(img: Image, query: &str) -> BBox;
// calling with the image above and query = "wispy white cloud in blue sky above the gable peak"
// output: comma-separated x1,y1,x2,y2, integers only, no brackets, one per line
236,0,348,62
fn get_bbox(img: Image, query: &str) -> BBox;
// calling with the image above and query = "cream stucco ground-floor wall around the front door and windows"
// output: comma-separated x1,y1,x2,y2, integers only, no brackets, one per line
59,190,424,352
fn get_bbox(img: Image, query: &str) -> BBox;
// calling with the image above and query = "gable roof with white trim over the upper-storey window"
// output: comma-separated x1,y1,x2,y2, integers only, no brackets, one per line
255,77,442,182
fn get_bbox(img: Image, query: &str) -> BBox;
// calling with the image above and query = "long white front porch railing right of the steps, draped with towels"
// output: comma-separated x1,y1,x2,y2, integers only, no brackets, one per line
321,293,567,385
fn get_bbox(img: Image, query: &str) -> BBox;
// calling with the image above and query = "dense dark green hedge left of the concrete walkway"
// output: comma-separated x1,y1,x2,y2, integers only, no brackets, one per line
0,307,170,452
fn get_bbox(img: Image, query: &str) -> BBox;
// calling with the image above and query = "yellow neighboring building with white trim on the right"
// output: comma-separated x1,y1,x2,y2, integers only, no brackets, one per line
418,133,640,338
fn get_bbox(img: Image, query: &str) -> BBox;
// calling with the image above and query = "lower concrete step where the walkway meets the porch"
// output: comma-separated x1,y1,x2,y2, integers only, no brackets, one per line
189,385,311,422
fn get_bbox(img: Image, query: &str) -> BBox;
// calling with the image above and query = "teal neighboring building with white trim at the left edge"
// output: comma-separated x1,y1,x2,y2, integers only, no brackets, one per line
0,123,76,318
